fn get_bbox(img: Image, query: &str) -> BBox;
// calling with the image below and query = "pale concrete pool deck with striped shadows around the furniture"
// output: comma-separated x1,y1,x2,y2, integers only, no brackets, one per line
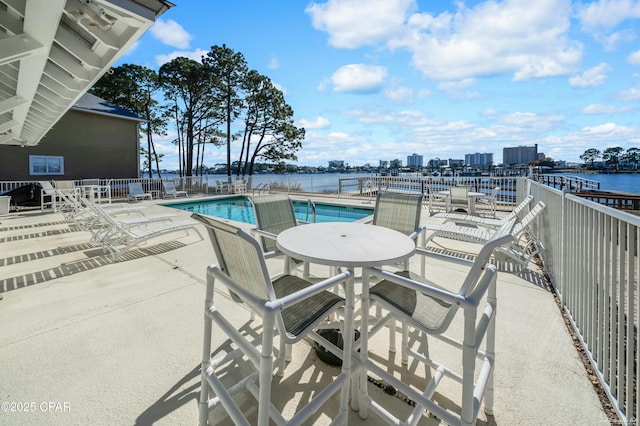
0,194,609,425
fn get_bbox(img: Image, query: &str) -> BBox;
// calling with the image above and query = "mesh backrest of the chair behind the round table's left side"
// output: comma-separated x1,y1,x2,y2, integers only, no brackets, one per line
249,194,298,251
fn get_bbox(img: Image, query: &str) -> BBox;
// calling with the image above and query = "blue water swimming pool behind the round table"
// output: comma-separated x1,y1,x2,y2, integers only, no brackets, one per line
165,196,373,224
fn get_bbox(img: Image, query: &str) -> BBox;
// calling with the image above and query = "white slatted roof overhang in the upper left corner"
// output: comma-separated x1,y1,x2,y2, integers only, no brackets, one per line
0,0,174,146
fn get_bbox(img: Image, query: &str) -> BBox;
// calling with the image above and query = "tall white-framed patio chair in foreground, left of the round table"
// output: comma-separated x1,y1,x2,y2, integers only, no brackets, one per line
192,214,351,426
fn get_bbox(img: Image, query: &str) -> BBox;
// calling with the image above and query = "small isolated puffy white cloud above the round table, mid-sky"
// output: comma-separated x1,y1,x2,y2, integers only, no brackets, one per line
331,64,387,94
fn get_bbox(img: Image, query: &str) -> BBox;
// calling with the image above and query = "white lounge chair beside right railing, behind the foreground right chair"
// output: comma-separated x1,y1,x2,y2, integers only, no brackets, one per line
423,201,546,267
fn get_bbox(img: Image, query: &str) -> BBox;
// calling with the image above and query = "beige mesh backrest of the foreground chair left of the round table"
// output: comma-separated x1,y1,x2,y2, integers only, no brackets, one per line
191,213,275,302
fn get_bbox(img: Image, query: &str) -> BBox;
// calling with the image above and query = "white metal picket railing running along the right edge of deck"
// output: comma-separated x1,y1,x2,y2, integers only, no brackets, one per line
529,181,640,424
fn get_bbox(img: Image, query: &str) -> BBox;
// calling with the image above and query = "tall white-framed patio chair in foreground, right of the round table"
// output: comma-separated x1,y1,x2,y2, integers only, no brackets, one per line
360,220,514,425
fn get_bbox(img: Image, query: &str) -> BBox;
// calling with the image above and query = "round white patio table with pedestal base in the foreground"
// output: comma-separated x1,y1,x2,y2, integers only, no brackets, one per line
276,222,415,421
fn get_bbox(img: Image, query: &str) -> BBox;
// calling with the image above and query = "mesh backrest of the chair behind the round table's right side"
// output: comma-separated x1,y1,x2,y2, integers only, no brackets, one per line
372,191,424,235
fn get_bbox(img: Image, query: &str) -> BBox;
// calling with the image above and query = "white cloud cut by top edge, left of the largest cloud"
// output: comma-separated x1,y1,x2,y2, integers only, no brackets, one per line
305,0,416,49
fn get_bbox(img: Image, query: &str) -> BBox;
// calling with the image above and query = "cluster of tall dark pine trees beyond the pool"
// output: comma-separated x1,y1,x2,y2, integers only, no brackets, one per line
90,44,305,181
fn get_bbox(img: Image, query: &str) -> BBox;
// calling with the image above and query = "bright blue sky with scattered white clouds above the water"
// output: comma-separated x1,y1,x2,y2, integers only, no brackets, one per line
116,0,640,168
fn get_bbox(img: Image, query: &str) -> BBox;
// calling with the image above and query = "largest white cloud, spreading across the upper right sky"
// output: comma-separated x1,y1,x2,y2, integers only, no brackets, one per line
389,0,582,80
